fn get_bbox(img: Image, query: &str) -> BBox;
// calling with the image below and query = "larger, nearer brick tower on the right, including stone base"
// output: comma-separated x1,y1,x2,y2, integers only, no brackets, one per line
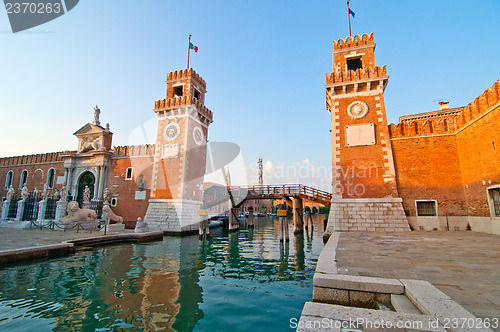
325,33,409,235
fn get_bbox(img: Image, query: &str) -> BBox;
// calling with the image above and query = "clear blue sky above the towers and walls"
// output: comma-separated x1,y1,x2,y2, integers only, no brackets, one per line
0,0,500,187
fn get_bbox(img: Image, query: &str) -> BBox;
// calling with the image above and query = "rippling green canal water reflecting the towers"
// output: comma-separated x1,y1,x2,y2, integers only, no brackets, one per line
0,215,325,332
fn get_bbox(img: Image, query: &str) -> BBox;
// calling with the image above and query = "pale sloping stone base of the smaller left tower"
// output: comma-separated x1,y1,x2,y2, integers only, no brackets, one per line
144,199,201,234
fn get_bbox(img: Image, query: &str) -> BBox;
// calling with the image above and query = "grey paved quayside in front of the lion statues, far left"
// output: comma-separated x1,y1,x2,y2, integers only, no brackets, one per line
0,227,110,251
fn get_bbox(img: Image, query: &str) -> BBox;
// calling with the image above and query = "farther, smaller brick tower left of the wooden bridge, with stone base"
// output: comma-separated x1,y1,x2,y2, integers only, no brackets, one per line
144,69,212,233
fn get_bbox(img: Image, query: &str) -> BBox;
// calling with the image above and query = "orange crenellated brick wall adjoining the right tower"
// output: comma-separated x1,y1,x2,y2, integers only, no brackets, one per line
390,81,500,217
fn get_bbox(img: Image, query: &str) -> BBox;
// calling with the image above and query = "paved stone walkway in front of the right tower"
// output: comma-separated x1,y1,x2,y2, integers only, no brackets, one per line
336,231,500,319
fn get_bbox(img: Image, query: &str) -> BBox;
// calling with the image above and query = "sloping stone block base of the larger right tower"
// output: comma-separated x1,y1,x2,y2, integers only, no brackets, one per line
325,198,410,236
